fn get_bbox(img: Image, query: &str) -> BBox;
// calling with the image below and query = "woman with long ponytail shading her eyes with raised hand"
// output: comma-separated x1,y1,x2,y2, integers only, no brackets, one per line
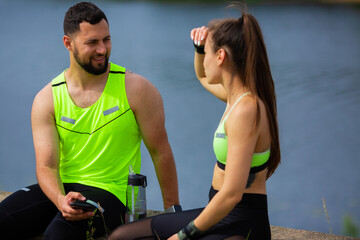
110,4,280,240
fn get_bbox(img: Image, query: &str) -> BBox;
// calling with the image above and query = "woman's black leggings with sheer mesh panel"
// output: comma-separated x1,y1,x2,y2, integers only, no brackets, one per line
109,188,271,240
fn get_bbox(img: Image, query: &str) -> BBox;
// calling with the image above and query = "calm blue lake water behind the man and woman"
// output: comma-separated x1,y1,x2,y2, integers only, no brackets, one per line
0,0,360,234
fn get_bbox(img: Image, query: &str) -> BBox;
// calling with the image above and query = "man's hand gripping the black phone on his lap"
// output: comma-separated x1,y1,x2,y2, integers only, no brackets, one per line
58,192,95,221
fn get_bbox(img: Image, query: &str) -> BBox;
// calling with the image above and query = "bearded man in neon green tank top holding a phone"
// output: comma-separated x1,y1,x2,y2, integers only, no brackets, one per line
0,2,179,239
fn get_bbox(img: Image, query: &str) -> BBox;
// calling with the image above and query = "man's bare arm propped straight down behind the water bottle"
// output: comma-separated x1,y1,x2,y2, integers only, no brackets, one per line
125,71,179,209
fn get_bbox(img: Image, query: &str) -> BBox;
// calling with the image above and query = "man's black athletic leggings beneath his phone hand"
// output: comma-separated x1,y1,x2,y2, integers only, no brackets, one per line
0,183,126,239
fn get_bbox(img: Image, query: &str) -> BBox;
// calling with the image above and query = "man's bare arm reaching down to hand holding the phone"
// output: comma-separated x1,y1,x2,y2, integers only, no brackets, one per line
31,84,93,220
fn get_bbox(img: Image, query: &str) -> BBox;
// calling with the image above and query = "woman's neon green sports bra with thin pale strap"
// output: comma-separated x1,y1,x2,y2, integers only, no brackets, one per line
213,92,270,167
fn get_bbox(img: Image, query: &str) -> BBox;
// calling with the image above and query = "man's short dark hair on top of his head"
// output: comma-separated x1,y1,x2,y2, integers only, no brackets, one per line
64,2,109,36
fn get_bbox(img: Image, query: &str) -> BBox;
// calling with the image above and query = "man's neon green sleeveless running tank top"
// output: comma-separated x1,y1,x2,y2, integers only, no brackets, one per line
52,63,141,204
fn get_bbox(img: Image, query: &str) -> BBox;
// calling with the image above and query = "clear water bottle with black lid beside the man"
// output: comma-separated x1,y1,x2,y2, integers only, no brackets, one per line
125,165,147,223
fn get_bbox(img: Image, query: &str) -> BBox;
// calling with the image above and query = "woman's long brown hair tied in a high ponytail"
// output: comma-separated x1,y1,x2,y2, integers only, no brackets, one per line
209,7,281,178
